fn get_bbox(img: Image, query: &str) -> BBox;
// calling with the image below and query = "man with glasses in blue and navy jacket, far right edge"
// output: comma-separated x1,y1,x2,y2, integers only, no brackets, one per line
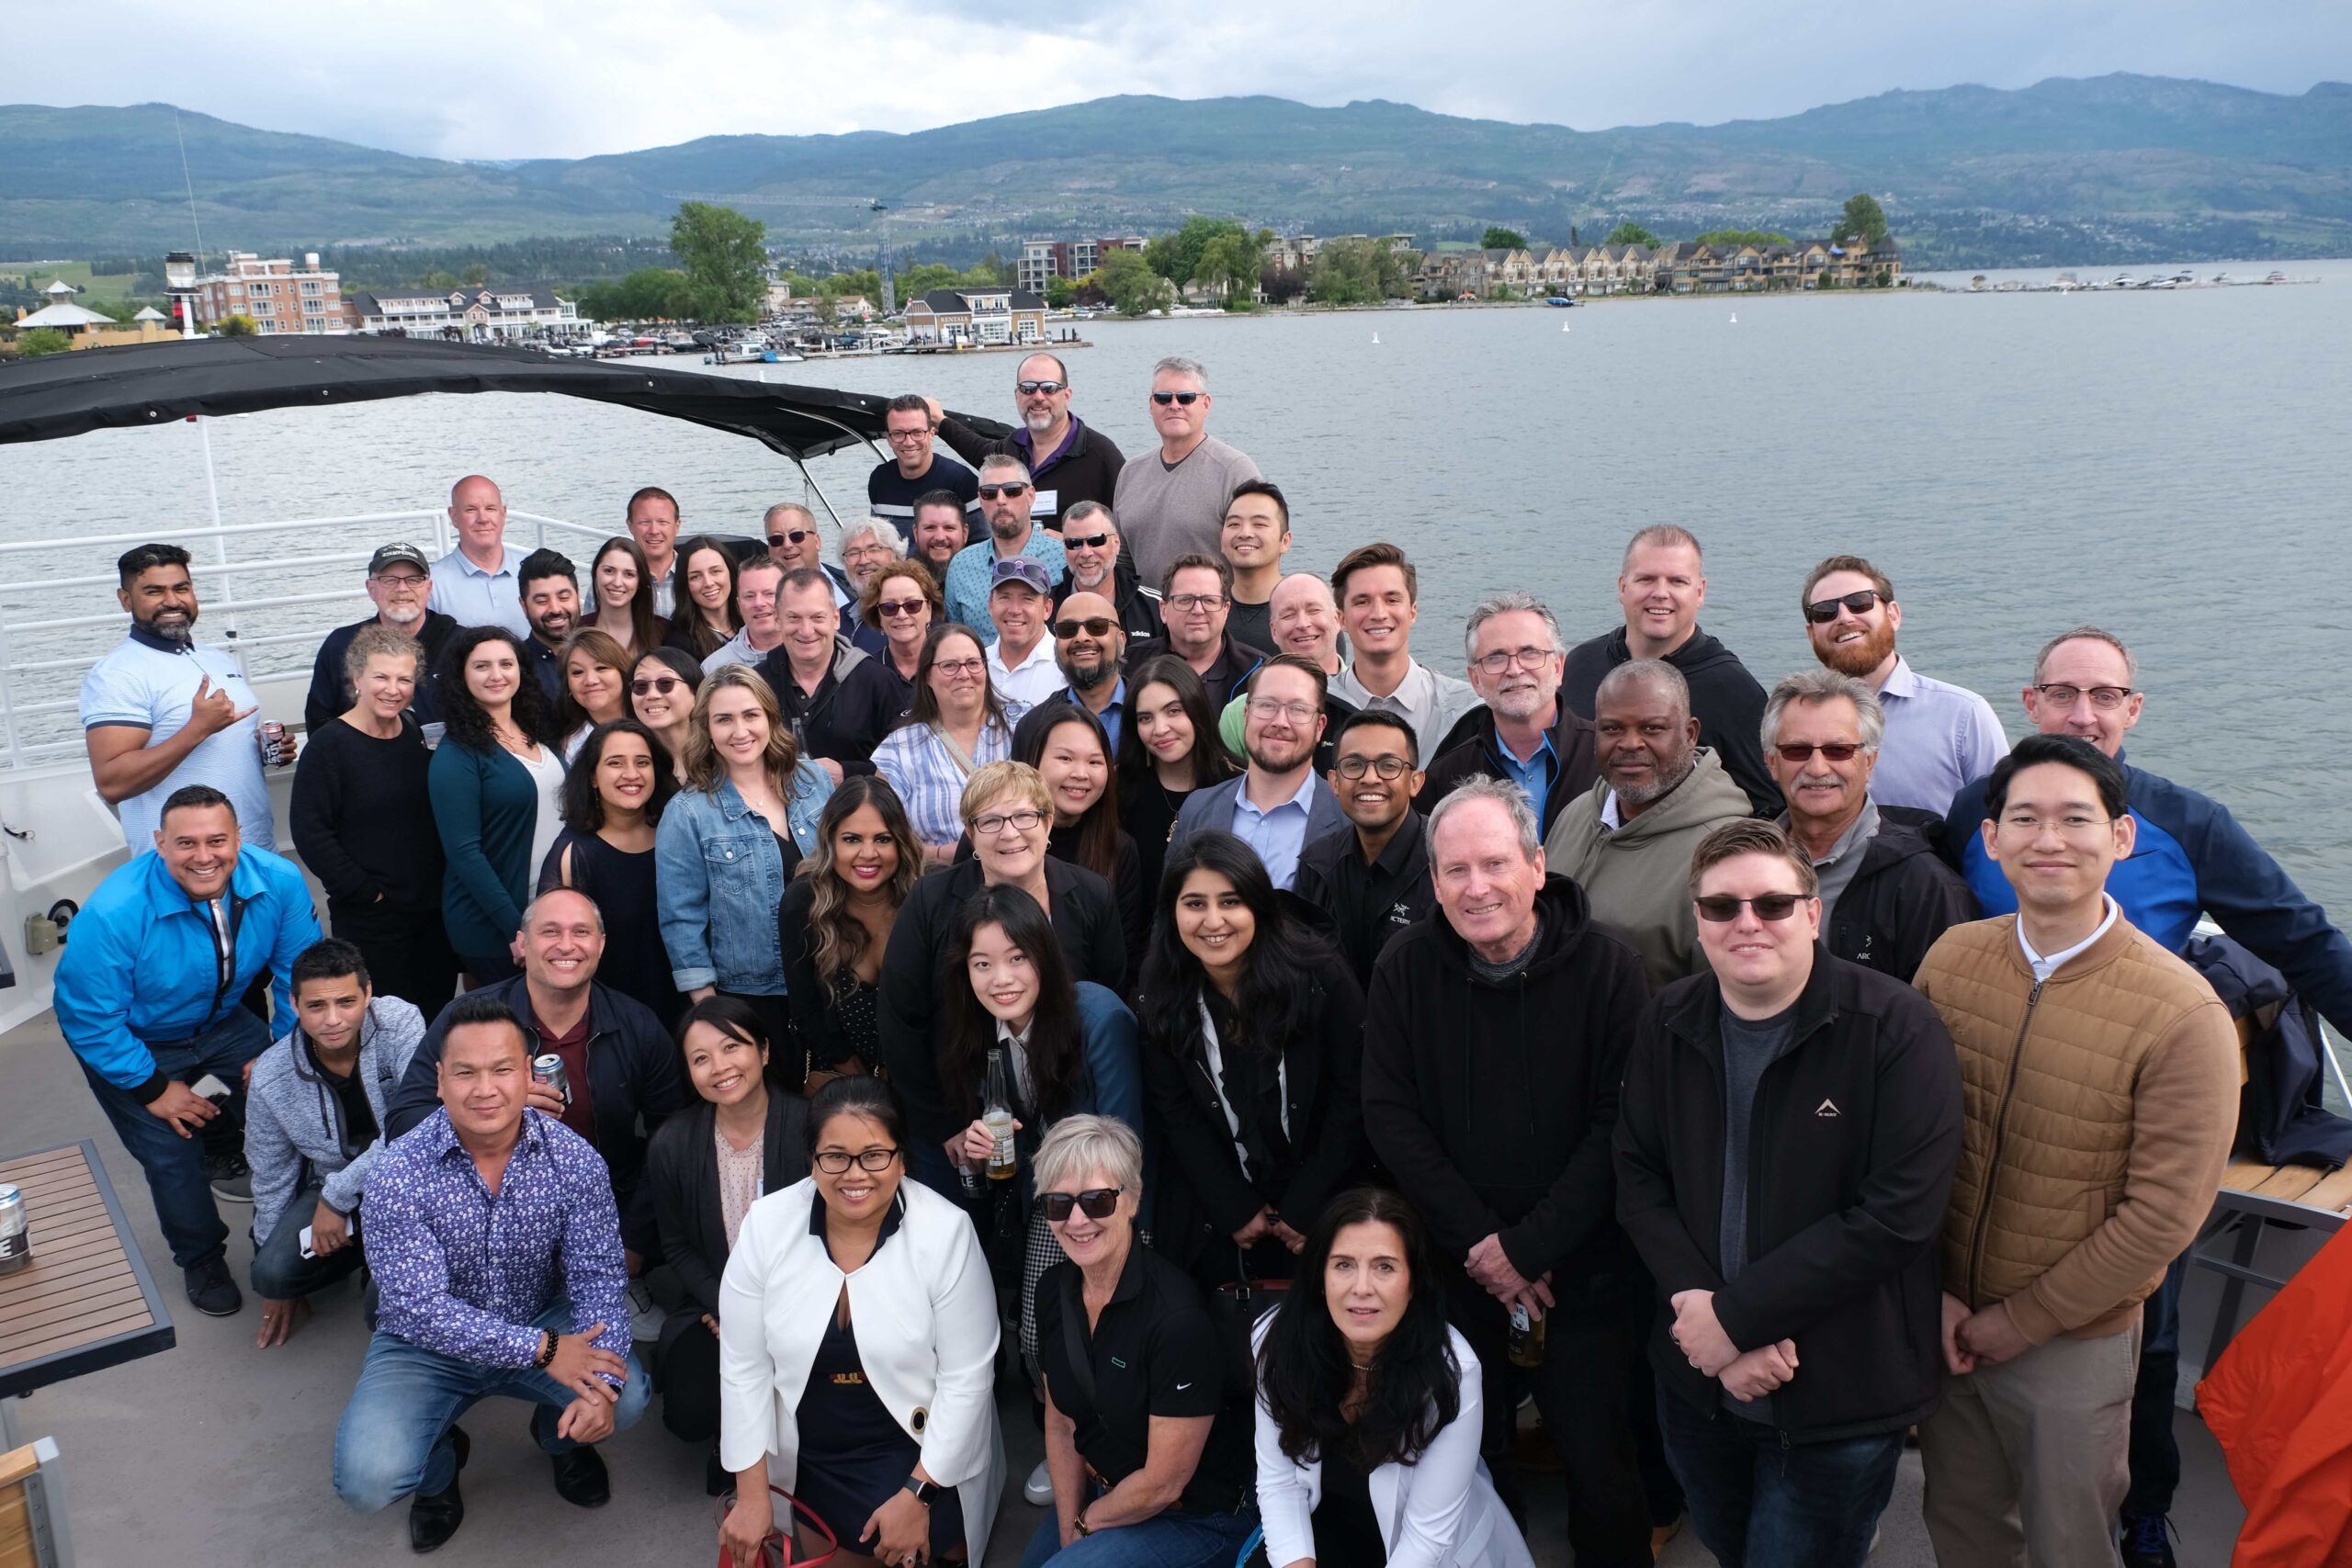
1945,626,2352,1568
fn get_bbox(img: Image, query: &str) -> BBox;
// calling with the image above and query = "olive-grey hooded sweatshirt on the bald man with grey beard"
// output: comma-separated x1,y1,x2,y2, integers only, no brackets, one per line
1543,745,1747,987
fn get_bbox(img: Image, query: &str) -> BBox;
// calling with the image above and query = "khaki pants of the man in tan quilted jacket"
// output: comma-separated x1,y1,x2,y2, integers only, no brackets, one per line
1919,1321,2141,1568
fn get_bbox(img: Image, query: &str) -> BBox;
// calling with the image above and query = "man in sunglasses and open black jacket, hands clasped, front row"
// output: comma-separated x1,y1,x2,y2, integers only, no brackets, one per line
1616,818,1959,1568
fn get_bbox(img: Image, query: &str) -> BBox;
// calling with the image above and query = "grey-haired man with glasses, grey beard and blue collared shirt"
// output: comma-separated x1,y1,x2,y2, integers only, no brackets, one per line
1414,590,1595,832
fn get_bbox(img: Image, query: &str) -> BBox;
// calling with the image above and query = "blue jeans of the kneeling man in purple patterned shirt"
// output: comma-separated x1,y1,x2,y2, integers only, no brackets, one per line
334,1303,651,1514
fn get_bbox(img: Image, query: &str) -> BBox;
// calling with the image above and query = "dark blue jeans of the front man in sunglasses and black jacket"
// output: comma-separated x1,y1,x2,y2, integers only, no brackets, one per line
1658,1387,1903,1568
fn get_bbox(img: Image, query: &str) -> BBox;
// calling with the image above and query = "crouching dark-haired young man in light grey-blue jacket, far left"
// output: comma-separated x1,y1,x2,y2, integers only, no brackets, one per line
244,938,425,1349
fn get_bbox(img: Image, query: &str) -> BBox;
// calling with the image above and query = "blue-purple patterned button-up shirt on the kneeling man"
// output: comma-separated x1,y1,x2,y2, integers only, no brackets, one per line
360,1110,630,1382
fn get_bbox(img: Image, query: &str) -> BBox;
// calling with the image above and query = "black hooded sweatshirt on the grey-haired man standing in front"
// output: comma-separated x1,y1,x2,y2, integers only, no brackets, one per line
1364,877,1649,1295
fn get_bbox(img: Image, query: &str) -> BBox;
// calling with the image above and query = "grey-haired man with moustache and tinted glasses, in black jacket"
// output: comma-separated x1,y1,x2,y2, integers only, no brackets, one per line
1764,670,1975,985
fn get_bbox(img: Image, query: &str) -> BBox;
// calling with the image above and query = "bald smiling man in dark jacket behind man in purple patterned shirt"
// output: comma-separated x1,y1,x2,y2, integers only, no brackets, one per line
383,888,687,1277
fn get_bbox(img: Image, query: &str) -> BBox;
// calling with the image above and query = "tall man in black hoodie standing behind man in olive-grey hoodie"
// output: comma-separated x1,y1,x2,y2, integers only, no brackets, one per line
1559,522,1781,816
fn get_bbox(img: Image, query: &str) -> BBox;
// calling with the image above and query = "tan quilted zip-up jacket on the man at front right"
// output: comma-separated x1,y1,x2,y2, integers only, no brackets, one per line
1919,915,2239,1345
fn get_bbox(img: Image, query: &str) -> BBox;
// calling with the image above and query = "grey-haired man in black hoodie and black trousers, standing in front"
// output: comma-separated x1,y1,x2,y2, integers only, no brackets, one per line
1364,778,1651,1568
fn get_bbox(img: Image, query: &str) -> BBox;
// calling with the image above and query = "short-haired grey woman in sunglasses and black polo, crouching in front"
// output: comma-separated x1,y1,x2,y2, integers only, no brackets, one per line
1021,1117,1261,1568
